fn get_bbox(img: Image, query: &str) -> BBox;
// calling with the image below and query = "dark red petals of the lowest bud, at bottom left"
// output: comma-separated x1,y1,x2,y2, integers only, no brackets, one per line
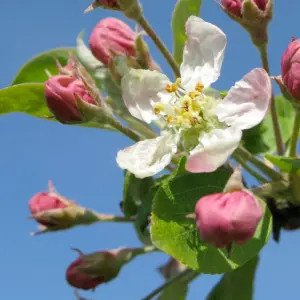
66,256,104,290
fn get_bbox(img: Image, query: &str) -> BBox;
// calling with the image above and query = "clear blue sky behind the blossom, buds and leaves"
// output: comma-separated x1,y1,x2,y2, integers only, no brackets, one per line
0,0,300,300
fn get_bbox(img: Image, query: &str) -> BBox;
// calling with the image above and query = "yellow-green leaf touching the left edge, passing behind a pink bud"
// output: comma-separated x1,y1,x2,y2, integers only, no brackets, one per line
0,83,115,130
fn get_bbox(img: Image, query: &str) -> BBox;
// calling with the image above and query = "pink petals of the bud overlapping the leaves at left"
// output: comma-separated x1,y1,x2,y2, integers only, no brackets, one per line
45,75,96,123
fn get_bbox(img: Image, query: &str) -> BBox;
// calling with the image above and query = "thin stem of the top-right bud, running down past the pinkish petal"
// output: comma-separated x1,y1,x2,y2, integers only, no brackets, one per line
258,44,284,155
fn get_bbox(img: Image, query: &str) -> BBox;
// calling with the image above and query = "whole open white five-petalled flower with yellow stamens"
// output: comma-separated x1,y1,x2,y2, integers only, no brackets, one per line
117,16,272,178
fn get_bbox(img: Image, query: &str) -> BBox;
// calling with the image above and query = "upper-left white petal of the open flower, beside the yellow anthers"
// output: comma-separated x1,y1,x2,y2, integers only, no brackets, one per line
121,69,170,123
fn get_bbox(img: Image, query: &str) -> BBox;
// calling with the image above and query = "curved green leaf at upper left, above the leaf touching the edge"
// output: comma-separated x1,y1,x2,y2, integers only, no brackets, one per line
12,48,74,85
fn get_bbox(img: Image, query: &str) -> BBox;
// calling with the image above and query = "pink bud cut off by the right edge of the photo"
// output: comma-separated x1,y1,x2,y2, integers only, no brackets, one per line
281,39,300,101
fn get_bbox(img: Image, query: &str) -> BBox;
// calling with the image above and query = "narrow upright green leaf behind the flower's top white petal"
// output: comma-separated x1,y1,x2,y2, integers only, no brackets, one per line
172,0,202,64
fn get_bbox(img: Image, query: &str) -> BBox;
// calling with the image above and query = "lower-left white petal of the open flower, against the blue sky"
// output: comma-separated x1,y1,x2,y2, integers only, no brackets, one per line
117,135,178,178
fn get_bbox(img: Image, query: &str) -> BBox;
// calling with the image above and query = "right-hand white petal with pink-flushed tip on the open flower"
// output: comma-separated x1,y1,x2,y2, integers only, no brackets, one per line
215,69,272,130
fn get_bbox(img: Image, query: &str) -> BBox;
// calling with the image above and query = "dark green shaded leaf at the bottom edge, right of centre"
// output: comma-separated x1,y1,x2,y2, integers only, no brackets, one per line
206,256,259,300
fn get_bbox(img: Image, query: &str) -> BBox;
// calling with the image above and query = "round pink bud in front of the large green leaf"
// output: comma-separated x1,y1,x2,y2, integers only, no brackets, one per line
195,190,263,248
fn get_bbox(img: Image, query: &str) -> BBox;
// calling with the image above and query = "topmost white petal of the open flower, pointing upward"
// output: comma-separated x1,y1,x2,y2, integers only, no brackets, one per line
180,16,227,91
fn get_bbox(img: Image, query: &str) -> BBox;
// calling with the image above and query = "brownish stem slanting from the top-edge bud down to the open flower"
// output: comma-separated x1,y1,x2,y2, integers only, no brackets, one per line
137,17,180,78
